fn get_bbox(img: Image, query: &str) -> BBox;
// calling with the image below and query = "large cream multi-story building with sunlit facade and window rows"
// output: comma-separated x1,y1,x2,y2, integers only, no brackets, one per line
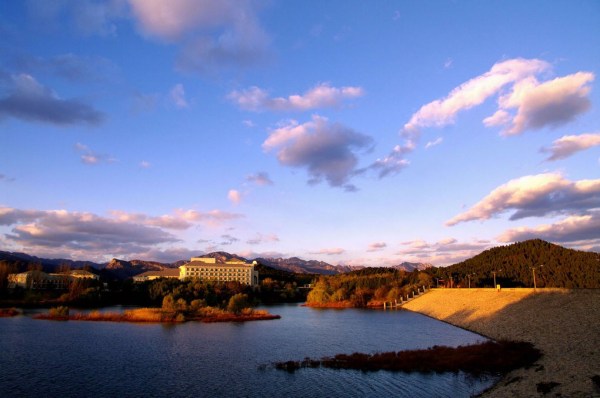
179,257,258,286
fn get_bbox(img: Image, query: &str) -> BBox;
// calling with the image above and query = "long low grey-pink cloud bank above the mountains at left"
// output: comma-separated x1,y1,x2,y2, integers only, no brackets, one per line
0,206,241,261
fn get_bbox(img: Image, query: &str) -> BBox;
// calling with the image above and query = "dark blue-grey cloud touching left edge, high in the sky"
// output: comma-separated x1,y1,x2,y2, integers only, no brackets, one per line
0,73,104,126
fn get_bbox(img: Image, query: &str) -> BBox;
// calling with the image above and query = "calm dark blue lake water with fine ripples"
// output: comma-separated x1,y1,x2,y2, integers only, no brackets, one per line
0,305,496,398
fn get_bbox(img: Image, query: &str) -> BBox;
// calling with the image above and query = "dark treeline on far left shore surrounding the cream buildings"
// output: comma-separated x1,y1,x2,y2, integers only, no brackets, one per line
0,262,314,308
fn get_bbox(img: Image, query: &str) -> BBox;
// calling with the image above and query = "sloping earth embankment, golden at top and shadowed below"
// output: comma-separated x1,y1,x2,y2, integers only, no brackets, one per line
403,289,600,397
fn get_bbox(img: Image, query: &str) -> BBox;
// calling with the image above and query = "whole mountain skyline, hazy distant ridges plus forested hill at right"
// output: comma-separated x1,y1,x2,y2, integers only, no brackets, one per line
0,239,600,287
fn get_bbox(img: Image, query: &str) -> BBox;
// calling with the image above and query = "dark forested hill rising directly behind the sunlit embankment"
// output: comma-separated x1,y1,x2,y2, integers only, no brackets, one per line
428,239,600,289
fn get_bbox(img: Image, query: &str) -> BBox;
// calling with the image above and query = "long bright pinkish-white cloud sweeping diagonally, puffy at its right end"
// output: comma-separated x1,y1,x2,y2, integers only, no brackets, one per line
380,58,594,178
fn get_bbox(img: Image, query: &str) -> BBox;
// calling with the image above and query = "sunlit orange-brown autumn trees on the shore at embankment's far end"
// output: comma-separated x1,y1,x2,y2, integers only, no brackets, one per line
306,268,432,307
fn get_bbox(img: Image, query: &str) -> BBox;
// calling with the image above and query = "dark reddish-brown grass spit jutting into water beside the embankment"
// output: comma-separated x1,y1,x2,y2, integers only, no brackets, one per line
274,341,541,375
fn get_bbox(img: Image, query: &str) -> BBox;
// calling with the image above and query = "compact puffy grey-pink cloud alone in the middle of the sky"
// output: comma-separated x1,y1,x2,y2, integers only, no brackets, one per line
263,115,372,191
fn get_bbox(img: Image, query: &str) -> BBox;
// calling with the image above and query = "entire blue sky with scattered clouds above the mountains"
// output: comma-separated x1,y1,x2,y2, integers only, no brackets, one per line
0,0,600,266
